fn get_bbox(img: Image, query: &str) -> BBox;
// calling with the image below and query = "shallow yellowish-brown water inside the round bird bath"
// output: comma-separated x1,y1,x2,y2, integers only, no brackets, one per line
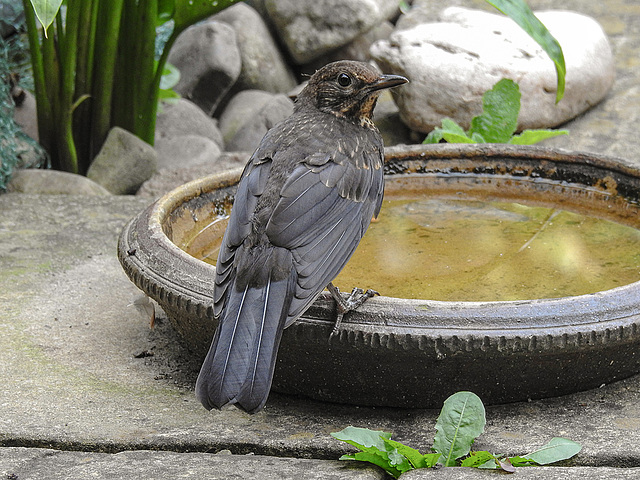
179,196,640,301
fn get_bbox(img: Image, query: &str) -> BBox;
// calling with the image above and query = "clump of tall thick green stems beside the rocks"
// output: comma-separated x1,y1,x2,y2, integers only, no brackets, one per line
23,0,237,173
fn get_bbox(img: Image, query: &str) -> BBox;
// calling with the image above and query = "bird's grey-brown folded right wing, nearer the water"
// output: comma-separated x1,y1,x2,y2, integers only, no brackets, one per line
266,146,384,325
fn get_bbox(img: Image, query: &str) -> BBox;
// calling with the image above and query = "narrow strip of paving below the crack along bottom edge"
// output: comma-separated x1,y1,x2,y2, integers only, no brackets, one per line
0,447,640,480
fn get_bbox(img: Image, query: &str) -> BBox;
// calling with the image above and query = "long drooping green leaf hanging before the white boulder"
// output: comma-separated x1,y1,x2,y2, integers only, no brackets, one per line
487,0,567,103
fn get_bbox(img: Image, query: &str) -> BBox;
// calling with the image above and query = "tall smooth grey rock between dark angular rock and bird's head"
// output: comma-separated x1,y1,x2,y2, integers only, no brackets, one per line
212,3,296,93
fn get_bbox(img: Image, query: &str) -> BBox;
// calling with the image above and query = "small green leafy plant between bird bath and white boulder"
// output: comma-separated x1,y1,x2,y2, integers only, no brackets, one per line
423,78,569,145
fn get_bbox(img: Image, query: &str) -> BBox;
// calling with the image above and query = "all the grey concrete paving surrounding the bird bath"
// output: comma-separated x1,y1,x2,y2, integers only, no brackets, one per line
0,0,640,480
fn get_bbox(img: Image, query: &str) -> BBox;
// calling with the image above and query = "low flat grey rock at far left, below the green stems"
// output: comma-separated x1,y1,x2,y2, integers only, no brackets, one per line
7,169,110,195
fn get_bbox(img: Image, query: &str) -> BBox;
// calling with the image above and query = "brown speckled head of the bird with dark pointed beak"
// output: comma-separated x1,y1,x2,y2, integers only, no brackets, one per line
297,60,408,122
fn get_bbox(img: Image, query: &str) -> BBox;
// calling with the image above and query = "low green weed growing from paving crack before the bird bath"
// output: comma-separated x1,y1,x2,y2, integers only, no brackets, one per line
331,392,582,478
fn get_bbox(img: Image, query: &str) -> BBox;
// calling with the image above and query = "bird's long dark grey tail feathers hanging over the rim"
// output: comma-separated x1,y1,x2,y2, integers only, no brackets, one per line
196,275,295,413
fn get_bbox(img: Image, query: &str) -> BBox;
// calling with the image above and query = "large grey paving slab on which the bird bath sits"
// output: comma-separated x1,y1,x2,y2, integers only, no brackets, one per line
0,194,640,474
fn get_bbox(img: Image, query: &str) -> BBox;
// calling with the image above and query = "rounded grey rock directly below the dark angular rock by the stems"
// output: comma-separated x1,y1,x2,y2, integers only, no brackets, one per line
155,98,224,149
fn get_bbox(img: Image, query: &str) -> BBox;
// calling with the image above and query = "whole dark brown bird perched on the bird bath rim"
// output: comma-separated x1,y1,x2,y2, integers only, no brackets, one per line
196,61,407,413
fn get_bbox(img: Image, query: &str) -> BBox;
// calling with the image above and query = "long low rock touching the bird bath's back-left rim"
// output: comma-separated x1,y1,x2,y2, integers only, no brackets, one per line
136,152,251,199
